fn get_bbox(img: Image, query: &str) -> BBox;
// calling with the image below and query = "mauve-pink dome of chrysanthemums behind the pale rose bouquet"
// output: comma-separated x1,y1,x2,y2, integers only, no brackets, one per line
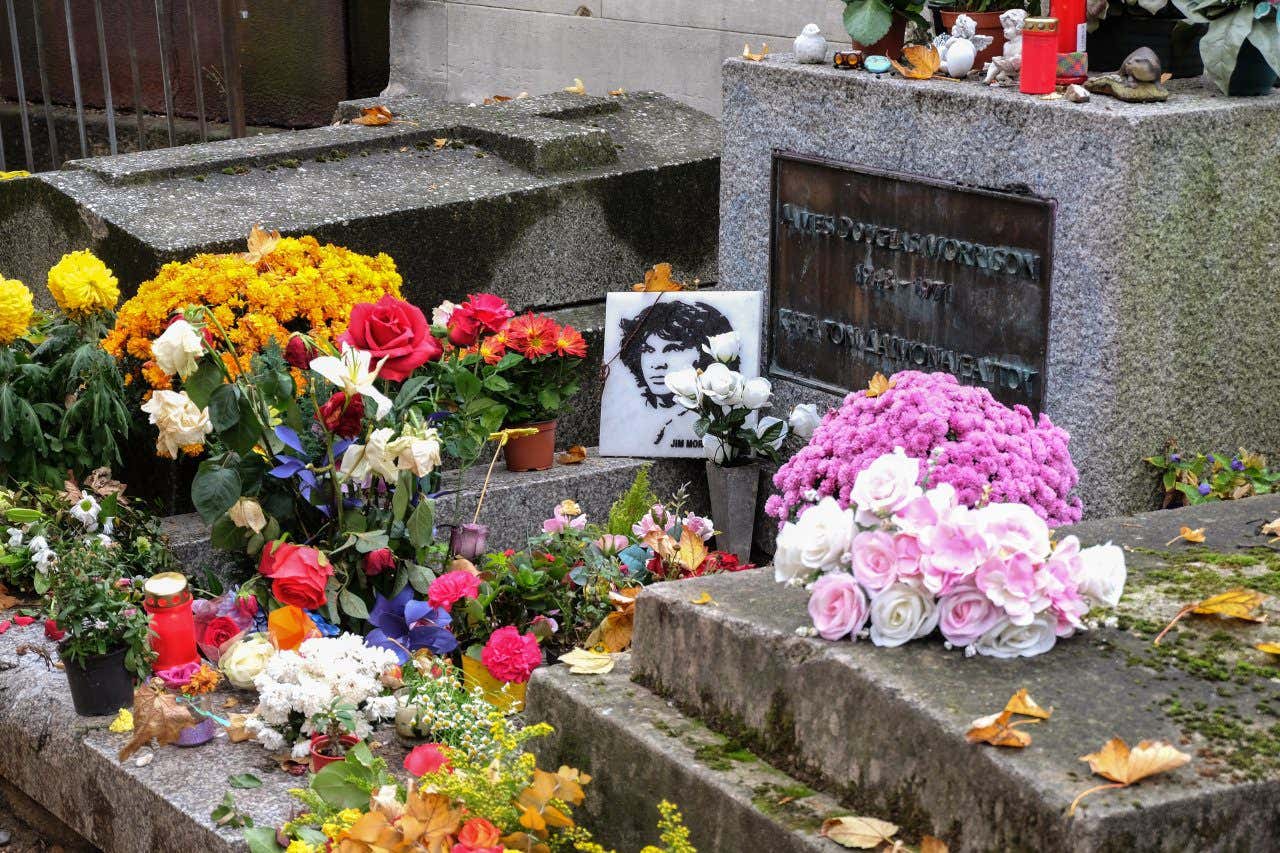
765,370,1080,526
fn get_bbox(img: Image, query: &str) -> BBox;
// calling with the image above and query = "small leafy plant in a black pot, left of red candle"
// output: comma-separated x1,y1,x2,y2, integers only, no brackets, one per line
46,540,152,717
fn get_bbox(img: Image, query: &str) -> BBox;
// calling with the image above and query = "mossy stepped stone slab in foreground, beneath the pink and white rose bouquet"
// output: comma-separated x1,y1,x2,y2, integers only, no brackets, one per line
529,496,1280,853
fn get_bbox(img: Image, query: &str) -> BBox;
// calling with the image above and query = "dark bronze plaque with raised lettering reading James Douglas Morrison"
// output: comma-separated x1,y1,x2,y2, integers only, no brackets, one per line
769,152,1055,412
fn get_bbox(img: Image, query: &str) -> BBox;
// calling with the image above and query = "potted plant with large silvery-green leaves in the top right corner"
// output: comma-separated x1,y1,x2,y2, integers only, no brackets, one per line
1174,0,1280,96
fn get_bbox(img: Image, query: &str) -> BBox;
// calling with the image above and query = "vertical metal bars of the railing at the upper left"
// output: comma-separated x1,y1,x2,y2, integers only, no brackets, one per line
0,0,247,172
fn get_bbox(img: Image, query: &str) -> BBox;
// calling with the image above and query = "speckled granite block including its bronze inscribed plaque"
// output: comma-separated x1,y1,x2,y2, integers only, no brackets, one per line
719,55,1280,517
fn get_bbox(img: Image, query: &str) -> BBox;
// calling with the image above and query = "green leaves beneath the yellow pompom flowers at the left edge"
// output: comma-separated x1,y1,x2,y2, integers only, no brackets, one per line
0,314,133,485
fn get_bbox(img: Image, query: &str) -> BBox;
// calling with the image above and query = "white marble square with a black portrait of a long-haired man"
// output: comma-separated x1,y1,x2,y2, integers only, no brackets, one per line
600,291,762,457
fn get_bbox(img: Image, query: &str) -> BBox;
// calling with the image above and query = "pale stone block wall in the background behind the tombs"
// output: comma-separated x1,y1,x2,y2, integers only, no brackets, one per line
390,0,847,115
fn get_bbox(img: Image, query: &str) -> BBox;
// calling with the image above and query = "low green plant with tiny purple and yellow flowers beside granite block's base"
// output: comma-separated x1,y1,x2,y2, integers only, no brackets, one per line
1144,442,1280,507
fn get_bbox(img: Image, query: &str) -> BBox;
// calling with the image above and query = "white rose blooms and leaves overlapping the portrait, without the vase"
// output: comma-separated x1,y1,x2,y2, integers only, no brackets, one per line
666,332,818,466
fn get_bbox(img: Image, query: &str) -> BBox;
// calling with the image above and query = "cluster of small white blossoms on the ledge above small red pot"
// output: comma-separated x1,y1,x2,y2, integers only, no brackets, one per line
244,634,397,749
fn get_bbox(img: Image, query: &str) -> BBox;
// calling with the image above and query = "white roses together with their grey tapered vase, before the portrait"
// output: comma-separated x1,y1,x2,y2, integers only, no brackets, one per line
666,332,788,562
